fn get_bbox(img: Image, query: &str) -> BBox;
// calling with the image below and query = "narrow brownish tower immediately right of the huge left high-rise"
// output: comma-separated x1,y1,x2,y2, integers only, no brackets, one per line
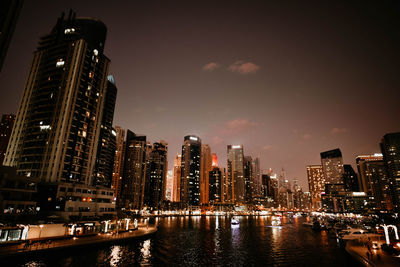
111,126,125,198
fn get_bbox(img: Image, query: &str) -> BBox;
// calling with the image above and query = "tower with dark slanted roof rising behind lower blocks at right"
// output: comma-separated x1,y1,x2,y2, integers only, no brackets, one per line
321,148,344,184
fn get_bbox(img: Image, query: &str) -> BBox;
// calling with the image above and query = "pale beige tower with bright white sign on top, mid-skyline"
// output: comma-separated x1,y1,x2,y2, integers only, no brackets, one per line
227,145,245,204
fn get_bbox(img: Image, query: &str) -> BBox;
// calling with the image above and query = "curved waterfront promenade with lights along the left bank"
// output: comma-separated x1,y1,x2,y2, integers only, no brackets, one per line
0,226,157,258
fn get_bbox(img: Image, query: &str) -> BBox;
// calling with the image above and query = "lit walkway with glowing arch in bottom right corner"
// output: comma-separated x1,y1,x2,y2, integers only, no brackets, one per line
346,241,400,267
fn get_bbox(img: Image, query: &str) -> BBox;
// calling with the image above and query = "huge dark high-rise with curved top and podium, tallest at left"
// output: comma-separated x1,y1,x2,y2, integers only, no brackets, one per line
4,12,115,220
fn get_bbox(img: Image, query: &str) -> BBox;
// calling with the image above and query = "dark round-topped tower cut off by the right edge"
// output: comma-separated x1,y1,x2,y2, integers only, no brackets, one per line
381,133,400,210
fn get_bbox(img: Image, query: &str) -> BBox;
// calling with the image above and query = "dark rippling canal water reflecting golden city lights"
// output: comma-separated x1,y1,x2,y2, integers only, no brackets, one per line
7,216,359,267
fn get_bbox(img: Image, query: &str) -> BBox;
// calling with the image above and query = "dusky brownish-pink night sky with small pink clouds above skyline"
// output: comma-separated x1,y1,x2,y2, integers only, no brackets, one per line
0,0,400,190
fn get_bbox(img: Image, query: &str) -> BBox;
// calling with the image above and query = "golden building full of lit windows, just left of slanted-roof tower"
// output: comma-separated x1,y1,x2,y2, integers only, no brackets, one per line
307,165,325,210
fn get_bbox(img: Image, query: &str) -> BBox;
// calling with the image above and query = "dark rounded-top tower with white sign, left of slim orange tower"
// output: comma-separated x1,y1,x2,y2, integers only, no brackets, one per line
180,135,201,207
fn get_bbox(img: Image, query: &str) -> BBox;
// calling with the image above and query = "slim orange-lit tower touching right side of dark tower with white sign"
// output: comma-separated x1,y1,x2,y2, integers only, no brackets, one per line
200,145,212,204
